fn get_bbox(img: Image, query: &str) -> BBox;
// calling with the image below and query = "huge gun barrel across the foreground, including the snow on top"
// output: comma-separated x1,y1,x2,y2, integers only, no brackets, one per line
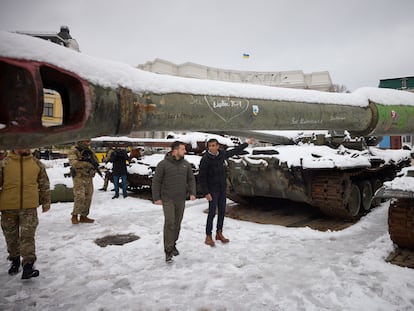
0,32,414,149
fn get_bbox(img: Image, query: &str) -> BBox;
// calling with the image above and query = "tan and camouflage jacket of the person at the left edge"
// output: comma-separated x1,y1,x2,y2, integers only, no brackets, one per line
0,153,50,210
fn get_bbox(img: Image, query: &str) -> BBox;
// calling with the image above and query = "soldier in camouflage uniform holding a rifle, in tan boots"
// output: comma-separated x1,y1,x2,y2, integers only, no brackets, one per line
68,140,98,224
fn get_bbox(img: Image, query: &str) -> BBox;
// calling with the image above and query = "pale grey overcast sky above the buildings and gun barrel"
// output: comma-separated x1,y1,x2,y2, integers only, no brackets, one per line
0,0,414,91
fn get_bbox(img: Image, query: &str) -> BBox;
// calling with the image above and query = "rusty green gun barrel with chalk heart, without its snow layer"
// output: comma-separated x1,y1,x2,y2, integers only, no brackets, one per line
0,36,414,149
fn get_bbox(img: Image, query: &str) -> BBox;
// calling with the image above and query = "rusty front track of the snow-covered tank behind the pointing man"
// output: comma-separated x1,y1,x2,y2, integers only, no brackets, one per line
311,173,353,220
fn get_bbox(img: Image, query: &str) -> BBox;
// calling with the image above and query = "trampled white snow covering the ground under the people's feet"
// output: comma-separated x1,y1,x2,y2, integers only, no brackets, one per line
0,160,414,311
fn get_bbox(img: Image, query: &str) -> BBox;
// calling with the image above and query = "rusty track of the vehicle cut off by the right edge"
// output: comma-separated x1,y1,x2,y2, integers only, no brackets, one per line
388,198,414,249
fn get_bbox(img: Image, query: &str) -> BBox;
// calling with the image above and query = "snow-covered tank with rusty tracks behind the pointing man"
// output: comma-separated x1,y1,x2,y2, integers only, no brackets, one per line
228,133,411,219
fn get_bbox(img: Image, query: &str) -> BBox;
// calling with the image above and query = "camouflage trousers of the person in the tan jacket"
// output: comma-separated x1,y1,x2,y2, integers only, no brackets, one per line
1,208,39,266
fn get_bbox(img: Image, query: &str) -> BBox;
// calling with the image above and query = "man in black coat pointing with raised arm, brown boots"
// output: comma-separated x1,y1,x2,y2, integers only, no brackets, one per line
199,138,252,246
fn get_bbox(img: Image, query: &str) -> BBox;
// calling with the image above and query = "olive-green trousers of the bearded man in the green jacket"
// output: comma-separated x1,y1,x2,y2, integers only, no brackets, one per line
162,199,185,253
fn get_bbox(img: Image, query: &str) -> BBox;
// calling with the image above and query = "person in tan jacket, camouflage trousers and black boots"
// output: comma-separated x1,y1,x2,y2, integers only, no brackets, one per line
0,149,50,279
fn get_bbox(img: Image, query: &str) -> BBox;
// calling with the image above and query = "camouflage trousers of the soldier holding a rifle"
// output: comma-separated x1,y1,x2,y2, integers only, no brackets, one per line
72,177,93,216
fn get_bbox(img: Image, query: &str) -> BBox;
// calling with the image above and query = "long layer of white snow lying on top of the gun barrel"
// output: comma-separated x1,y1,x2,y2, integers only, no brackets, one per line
0,31,414,107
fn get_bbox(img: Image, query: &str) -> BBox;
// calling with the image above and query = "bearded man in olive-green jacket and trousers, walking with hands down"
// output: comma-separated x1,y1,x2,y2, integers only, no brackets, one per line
152,141,196,262
